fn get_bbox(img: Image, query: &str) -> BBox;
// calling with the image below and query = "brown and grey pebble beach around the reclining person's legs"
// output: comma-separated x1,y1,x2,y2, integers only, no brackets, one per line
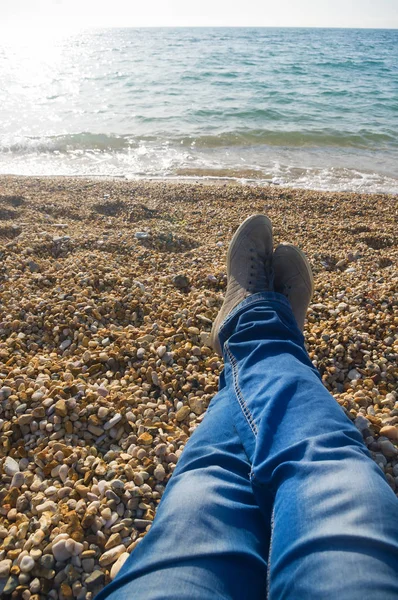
0,176,398,600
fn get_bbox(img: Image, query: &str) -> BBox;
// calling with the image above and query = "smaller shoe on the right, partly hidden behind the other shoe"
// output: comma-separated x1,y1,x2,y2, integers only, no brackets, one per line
274,244,314,331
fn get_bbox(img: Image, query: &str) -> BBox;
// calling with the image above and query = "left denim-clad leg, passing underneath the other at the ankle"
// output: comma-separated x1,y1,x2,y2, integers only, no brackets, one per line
96,388,270,600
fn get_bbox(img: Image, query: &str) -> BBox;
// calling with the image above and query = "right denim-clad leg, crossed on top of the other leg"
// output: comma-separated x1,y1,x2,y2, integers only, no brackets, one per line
220,292,398,600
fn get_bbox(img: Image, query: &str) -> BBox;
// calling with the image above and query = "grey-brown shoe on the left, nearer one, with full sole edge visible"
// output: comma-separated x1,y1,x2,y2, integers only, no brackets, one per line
210,215,273,355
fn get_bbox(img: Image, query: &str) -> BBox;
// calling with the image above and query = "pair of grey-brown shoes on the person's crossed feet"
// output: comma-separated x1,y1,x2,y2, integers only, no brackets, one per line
211,215,314,355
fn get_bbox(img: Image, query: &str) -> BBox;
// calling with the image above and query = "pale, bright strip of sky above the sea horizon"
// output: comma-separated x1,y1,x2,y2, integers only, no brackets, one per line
0,0,398,31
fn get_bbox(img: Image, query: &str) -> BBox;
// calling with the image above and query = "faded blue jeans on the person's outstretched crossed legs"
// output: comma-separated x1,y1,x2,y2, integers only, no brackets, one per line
97,292,398,600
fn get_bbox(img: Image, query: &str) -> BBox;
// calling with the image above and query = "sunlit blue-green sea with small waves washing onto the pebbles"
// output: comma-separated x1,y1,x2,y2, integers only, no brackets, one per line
0,28,398,193
